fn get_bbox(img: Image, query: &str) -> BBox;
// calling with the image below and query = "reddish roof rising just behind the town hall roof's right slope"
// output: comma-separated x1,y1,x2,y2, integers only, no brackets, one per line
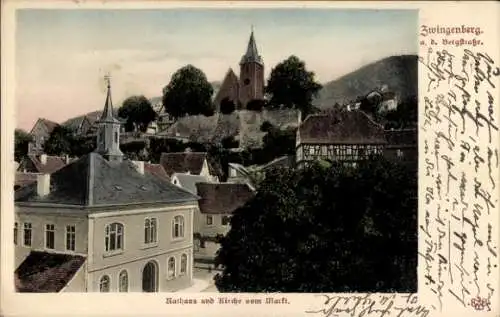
160,152,208,176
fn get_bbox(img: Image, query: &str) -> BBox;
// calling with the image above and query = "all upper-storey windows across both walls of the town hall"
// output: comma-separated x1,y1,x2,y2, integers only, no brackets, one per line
14,216,185,252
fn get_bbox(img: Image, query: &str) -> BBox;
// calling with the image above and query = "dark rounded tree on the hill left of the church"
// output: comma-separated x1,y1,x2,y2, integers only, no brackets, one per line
163,65,214,118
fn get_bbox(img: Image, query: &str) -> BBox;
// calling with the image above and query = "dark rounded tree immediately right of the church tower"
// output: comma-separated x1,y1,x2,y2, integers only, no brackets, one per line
266,55,322,115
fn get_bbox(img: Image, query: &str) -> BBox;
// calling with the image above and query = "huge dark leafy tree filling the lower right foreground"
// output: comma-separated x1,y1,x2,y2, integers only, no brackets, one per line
215,158,418,293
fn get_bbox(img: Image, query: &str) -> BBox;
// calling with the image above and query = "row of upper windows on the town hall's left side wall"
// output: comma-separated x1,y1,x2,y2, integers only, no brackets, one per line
14,222,76,251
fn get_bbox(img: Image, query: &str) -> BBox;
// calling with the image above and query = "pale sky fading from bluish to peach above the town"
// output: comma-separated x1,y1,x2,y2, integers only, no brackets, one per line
16,8,418,130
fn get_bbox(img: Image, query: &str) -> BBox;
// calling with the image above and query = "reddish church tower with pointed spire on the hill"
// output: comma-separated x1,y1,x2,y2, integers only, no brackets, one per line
239,28,264,109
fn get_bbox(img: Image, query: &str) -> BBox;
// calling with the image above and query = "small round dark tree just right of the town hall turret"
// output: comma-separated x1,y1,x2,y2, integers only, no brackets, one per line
118,96,156,132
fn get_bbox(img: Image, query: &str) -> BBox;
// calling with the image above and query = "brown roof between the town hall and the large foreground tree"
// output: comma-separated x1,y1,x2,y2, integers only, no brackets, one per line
196,183,255,214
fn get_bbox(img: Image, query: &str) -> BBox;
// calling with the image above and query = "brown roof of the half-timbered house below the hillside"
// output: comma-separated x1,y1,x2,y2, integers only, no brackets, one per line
299,110,386,144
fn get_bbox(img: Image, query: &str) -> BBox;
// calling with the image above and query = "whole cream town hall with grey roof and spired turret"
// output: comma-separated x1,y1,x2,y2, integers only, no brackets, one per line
14,78,198,292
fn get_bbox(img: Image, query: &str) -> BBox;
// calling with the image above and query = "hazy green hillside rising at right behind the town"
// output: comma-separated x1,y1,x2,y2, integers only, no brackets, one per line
314,55,418,108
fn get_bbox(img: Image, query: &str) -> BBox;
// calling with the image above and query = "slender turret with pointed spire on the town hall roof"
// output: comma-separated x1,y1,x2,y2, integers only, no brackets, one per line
95,76,123,162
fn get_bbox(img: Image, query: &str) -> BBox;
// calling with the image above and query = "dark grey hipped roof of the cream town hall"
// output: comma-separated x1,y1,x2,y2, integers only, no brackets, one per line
15,152,198,207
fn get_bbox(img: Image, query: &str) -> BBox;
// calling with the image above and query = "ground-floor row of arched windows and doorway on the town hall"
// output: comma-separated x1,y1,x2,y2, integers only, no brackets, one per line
99,254,188,293
